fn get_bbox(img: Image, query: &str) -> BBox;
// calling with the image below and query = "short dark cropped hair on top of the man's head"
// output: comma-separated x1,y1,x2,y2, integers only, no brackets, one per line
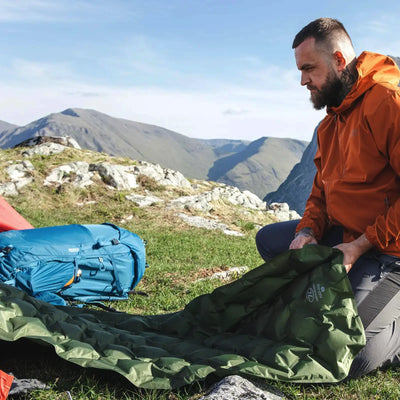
292,18,351,49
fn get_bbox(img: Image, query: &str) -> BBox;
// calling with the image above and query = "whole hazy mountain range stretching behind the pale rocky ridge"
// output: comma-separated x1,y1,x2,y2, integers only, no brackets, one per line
0,108,305,197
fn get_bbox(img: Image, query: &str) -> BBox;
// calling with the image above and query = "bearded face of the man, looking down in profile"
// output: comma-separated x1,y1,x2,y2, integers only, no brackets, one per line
295,38,343,110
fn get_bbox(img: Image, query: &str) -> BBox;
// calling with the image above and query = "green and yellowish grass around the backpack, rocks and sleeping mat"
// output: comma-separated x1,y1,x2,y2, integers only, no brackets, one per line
0,145,400,400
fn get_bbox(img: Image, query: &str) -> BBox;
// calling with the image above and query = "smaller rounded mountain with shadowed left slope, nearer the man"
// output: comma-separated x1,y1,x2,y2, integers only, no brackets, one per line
208,137,307,197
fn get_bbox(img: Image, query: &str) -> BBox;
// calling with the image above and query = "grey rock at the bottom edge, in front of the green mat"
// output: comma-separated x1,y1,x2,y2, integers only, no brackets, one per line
199,375,285,400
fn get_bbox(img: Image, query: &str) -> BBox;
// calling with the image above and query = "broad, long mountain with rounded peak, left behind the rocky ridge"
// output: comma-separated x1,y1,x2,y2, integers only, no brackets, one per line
0,108,216,178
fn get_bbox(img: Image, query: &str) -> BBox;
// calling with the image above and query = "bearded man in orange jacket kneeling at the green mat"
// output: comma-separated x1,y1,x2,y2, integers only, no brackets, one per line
256,18,400,377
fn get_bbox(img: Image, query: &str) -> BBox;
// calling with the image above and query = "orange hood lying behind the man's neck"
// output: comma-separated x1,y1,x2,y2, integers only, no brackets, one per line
330,51,400,113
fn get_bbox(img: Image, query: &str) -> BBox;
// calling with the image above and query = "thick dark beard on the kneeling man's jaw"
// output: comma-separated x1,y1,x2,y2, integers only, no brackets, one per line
309,69,354,110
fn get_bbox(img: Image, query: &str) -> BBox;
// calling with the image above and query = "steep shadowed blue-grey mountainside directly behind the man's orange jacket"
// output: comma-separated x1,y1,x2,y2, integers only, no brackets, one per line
264,56,400,214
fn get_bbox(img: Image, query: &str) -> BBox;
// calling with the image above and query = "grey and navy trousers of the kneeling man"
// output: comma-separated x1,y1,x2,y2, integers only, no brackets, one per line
256,220,400,378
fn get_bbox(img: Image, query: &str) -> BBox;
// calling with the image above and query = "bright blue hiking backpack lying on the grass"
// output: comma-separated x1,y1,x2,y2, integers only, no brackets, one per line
0,224,146,305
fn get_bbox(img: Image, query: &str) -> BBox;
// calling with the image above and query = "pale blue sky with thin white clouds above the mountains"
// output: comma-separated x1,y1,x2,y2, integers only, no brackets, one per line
0,0,400,140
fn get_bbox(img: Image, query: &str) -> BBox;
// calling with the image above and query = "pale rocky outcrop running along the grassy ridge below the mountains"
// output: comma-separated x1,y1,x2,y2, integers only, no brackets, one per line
0,141,299,236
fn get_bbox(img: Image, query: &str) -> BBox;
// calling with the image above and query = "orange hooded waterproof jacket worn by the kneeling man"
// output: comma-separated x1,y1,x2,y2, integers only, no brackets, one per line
297,52,400,256
